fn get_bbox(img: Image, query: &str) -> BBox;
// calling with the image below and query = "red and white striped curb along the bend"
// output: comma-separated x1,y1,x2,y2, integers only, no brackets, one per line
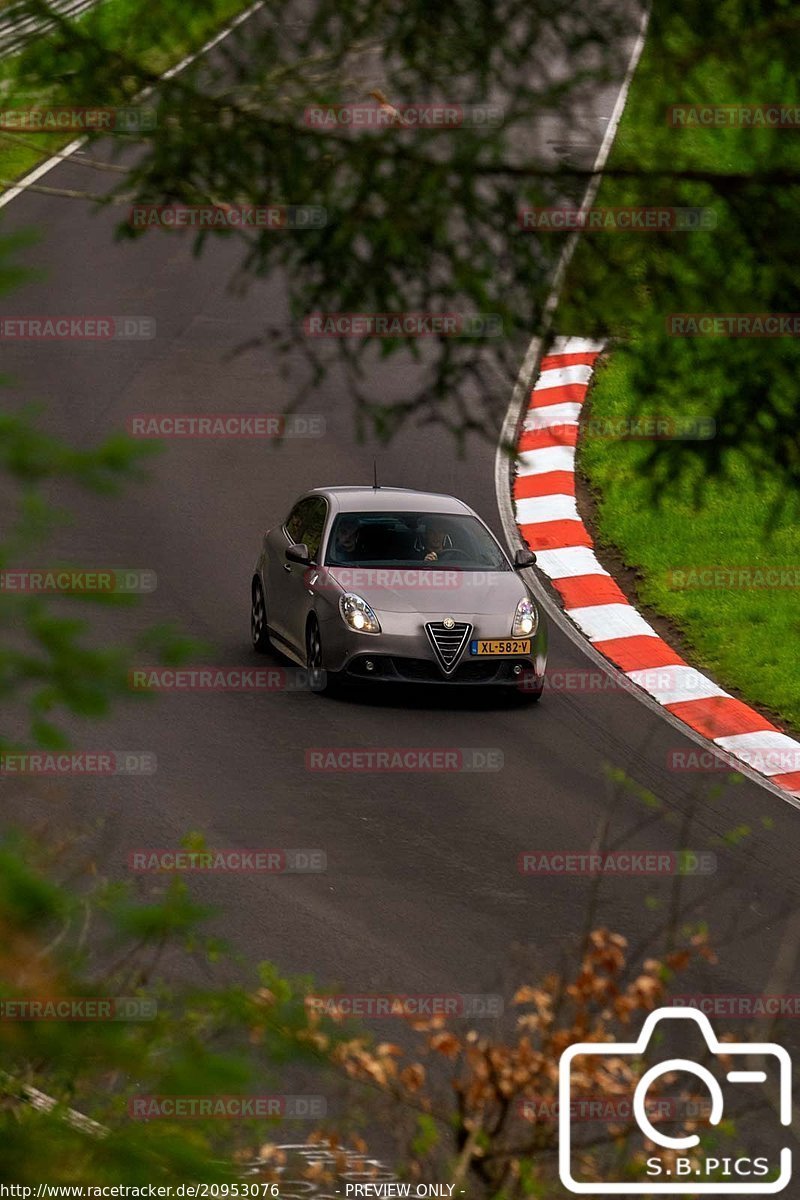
513,337,800,797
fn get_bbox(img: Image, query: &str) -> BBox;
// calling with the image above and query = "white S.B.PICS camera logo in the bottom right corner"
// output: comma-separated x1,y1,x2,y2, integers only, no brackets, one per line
559,1008,792,1198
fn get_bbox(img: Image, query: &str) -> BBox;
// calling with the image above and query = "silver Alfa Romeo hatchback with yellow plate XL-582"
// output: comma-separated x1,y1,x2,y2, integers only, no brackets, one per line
251,487,547,701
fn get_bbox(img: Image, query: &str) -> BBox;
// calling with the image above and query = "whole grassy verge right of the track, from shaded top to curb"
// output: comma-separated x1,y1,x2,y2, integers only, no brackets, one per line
558,0,800,730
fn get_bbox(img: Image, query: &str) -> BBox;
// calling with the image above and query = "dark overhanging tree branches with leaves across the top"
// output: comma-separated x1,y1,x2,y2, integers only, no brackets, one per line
6,0,800,488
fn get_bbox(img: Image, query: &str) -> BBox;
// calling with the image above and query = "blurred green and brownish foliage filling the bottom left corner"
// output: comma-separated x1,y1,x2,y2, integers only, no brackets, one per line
0,839,345,1184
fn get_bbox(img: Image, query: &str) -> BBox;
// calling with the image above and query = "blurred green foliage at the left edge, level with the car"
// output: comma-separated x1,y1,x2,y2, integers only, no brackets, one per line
0,384,199,750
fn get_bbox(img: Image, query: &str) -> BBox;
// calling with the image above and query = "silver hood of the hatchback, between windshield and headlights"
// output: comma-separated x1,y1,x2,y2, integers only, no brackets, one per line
318,566,528,620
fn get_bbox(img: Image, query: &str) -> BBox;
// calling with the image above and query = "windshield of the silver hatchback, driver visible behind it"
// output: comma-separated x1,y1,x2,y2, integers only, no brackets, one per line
325,512,511,571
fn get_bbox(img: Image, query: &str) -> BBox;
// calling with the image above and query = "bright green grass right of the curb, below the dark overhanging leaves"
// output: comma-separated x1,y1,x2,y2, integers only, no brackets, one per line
579,354,800,728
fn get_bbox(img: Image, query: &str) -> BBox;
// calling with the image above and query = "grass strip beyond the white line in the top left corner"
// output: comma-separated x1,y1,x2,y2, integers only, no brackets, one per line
0,0,251,190
